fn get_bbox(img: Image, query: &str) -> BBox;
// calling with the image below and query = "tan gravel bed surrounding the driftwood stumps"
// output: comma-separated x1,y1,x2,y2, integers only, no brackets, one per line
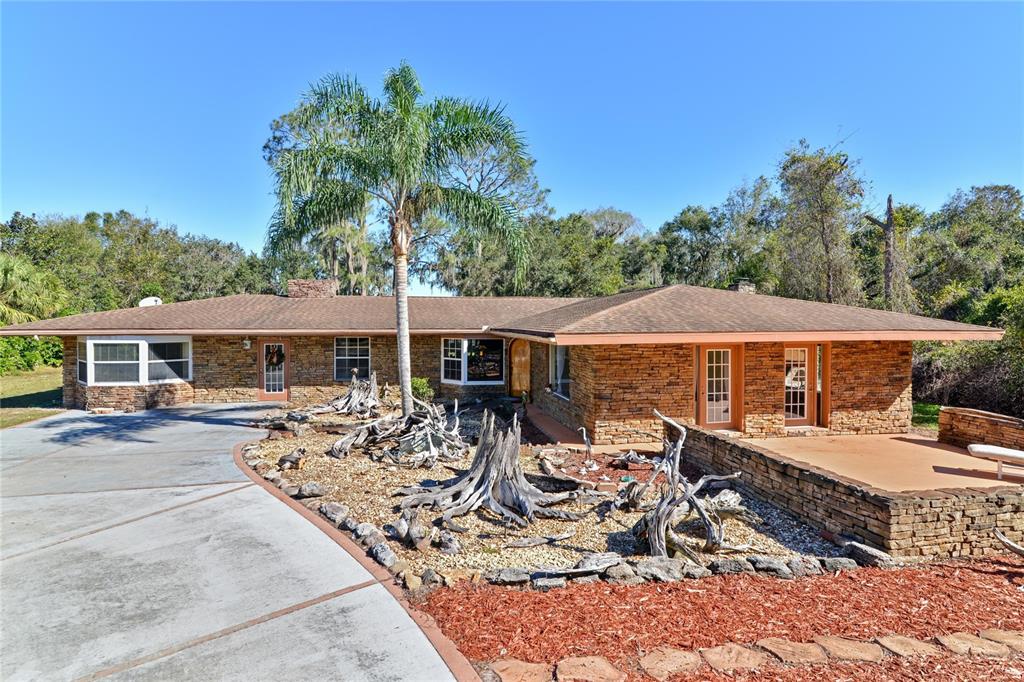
250,415,841,573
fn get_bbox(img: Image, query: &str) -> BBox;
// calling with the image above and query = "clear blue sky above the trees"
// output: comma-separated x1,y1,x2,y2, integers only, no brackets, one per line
0,2,1024,259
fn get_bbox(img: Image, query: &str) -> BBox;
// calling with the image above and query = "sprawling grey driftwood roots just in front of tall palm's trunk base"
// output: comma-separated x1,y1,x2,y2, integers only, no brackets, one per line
328,398,469,468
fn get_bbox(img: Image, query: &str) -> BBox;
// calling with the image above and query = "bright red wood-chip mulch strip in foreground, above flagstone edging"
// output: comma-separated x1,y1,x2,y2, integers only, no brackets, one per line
420,557,1024,680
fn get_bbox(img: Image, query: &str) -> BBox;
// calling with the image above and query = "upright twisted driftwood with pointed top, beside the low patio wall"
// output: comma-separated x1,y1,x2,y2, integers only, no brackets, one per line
632,410,743,561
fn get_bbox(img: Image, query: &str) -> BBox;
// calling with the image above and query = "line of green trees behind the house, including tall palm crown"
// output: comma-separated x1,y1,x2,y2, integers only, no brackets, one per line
0,65,1024,414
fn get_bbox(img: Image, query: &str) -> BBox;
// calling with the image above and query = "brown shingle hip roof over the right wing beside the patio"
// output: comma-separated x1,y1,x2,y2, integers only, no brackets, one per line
495,285,998,337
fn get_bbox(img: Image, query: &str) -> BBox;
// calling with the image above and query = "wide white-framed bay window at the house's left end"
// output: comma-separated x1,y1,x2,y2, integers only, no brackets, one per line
77,336,191,386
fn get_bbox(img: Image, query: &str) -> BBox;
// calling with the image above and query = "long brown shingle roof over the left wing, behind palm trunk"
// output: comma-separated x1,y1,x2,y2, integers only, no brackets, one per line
0,294,580,336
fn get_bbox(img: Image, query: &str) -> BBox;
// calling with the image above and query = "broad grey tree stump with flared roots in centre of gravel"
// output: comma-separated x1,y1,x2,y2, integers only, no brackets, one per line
397,411,580,531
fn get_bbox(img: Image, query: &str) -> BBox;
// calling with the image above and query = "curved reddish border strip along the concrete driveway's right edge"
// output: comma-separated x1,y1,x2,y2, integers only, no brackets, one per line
231,440,480,682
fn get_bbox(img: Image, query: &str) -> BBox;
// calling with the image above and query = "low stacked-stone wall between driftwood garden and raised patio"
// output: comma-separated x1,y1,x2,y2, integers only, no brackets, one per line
683,428,1024,557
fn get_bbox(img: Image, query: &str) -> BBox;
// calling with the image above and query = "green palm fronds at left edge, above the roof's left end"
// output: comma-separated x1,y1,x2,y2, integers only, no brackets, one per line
0,252,68,326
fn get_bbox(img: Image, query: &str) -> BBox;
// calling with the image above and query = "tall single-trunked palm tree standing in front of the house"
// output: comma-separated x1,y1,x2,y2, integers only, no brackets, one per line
271,62,525,415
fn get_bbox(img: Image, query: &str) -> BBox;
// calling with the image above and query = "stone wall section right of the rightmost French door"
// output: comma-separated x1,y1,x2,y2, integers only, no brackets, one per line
828,341,913,433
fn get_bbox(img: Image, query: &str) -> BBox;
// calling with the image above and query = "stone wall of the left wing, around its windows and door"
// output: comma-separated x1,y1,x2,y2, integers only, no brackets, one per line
63,335,508,411
